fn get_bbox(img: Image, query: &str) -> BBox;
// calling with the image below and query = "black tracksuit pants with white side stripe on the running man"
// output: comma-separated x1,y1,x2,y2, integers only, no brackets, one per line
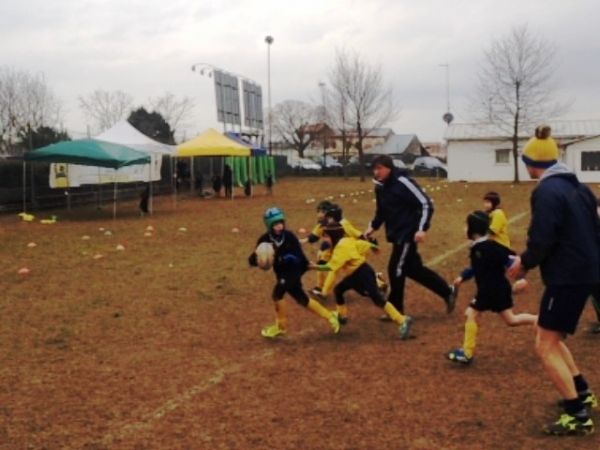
388,241,452,313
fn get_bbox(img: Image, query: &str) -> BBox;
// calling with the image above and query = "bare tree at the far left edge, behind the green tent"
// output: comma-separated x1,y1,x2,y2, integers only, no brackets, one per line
0,67,61,152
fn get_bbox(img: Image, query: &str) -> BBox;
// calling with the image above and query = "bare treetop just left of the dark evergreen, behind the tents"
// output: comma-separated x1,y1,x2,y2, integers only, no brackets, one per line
79,89,133,132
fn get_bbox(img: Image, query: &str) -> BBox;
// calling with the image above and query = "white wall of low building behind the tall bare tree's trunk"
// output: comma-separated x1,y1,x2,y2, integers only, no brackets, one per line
448,141,530,181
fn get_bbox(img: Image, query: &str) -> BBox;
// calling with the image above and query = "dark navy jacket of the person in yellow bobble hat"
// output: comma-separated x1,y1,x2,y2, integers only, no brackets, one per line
521,163,600,285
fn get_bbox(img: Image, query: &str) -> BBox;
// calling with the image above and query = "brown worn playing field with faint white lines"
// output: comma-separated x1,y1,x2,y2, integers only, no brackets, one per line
0,179,600,450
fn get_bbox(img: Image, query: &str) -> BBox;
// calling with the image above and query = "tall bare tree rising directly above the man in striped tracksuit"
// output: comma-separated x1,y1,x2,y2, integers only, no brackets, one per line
328,50,399,181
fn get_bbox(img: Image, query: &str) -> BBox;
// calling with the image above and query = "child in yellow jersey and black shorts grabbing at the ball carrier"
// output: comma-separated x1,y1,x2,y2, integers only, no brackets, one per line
309,212,412,339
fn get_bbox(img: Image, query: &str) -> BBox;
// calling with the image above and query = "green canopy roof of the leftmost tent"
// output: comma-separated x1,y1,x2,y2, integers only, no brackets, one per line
24,139,150,169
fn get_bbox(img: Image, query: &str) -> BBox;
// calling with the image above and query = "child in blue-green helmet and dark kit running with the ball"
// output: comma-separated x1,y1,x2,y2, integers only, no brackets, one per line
248,208,340,339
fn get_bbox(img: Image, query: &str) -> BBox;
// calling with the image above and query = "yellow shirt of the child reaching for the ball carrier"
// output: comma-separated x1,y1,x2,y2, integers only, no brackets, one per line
320,237,373,295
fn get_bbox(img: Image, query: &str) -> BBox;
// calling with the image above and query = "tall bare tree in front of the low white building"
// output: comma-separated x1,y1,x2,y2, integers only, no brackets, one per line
472,25,568,183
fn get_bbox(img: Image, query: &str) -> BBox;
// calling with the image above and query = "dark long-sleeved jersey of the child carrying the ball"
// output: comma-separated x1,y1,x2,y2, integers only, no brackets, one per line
248,230,308,280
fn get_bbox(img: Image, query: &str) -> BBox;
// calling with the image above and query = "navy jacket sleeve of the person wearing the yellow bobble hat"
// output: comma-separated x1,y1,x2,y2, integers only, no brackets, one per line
521,185,565,270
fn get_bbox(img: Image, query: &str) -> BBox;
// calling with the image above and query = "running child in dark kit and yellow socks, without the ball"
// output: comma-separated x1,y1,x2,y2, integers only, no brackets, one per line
447,211,537,364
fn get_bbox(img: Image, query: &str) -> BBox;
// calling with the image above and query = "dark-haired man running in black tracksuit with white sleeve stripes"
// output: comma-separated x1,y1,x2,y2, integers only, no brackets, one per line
365,155,456,313
